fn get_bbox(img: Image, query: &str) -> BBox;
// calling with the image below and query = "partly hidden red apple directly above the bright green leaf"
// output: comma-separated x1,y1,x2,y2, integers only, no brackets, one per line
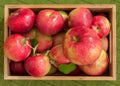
49,44,70,67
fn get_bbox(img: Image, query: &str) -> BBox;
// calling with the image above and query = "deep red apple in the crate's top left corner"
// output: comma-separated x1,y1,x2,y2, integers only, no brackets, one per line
8,8,36,33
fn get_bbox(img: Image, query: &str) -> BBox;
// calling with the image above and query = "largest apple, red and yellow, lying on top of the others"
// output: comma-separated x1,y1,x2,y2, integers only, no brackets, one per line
63,27,102,65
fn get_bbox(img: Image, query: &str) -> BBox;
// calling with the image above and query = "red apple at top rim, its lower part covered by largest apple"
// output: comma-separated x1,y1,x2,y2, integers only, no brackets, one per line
68,8,93,27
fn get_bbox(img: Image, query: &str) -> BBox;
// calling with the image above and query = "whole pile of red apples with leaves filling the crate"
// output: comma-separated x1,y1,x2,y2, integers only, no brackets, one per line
4,7,110,77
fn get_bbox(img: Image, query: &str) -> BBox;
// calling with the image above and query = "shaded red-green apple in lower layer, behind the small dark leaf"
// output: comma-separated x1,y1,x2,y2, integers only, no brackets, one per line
24,27,53,53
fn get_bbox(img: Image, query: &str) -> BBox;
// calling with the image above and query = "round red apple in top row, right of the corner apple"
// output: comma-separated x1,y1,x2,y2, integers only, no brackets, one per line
36,9,64,35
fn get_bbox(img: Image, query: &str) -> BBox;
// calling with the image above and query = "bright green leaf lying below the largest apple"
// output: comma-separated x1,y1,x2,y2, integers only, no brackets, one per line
58,63,76,74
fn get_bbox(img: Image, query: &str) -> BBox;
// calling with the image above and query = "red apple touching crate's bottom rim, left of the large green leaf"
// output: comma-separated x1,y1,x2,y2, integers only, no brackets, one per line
24,54,51,77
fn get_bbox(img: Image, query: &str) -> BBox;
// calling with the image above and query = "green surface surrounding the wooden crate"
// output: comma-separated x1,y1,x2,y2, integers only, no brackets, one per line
0,0,120,86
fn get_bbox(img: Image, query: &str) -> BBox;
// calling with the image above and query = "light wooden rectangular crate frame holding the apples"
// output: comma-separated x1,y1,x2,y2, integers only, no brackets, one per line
4,4,116,80
